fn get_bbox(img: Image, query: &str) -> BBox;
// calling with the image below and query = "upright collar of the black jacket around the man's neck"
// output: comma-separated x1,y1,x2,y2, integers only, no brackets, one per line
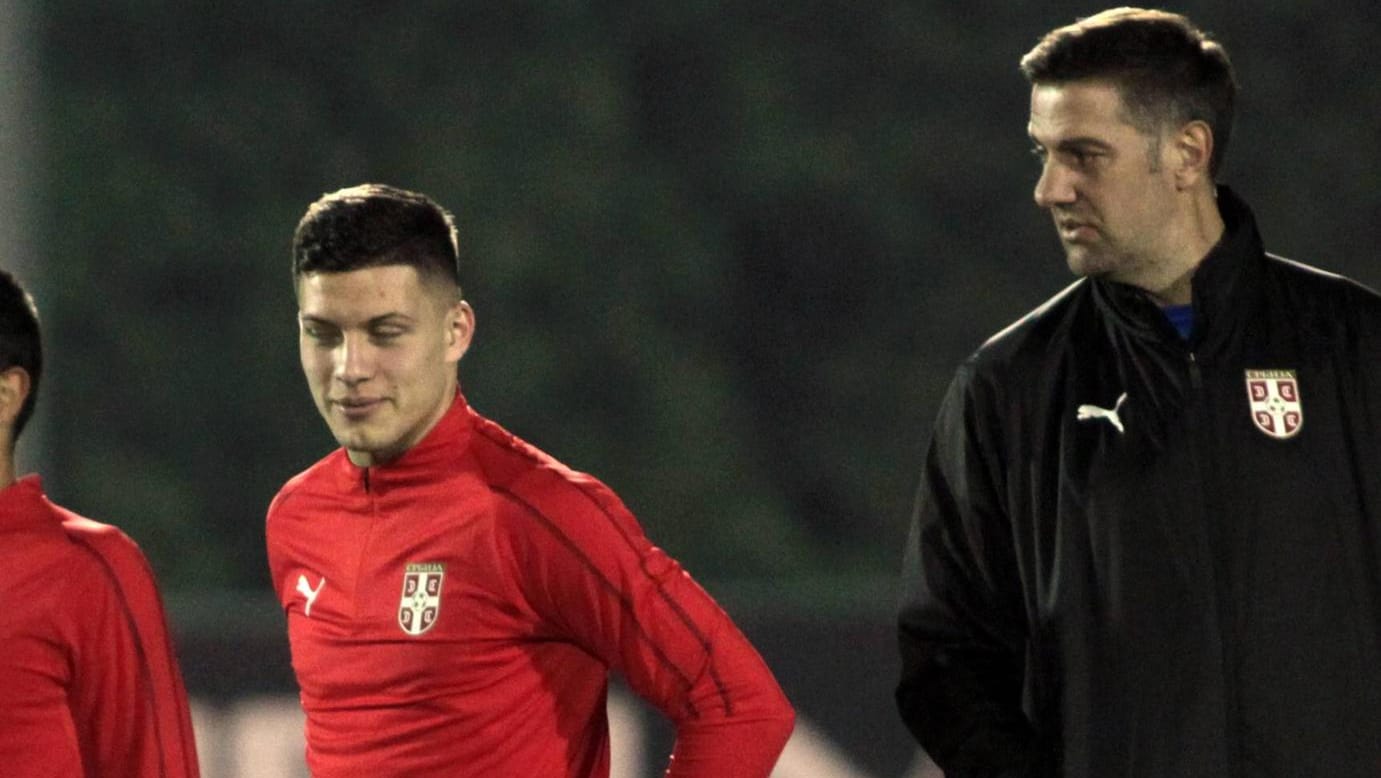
1092,187,1265,355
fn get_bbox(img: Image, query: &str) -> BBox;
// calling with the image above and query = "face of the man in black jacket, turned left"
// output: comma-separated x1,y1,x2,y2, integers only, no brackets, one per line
1027,82,1178,287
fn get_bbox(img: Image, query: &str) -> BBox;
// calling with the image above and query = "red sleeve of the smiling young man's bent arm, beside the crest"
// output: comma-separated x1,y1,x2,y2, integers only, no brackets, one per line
518,475,794,778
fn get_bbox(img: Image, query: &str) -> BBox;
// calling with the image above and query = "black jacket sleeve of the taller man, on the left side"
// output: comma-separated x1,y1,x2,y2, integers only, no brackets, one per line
896,363,1036,778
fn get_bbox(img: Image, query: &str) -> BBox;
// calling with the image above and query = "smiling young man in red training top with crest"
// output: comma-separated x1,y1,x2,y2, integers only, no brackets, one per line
267,184,794,778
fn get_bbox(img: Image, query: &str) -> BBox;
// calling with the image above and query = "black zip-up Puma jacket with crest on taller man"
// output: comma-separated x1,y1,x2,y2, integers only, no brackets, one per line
896,188,1381,778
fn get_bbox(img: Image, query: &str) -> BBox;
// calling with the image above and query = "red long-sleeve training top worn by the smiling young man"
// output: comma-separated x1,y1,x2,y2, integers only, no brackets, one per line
268,395,794,778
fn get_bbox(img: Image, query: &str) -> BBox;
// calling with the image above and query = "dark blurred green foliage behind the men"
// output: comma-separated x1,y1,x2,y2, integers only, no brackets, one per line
26,0,1381,590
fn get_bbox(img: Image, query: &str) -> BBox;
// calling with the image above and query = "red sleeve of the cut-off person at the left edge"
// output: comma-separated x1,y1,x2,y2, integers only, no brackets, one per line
65,521,199,778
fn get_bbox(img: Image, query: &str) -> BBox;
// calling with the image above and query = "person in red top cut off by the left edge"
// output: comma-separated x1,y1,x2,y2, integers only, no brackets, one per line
0,271,197,778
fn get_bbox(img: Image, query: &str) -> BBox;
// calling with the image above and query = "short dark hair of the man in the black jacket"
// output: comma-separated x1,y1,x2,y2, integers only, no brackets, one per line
1021,8,1237,175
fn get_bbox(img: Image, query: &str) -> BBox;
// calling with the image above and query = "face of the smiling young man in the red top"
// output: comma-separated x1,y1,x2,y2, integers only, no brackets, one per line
297,265,475,466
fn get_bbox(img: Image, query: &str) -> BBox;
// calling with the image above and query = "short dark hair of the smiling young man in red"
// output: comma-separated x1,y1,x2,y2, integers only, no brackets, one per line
293,184,460,289
